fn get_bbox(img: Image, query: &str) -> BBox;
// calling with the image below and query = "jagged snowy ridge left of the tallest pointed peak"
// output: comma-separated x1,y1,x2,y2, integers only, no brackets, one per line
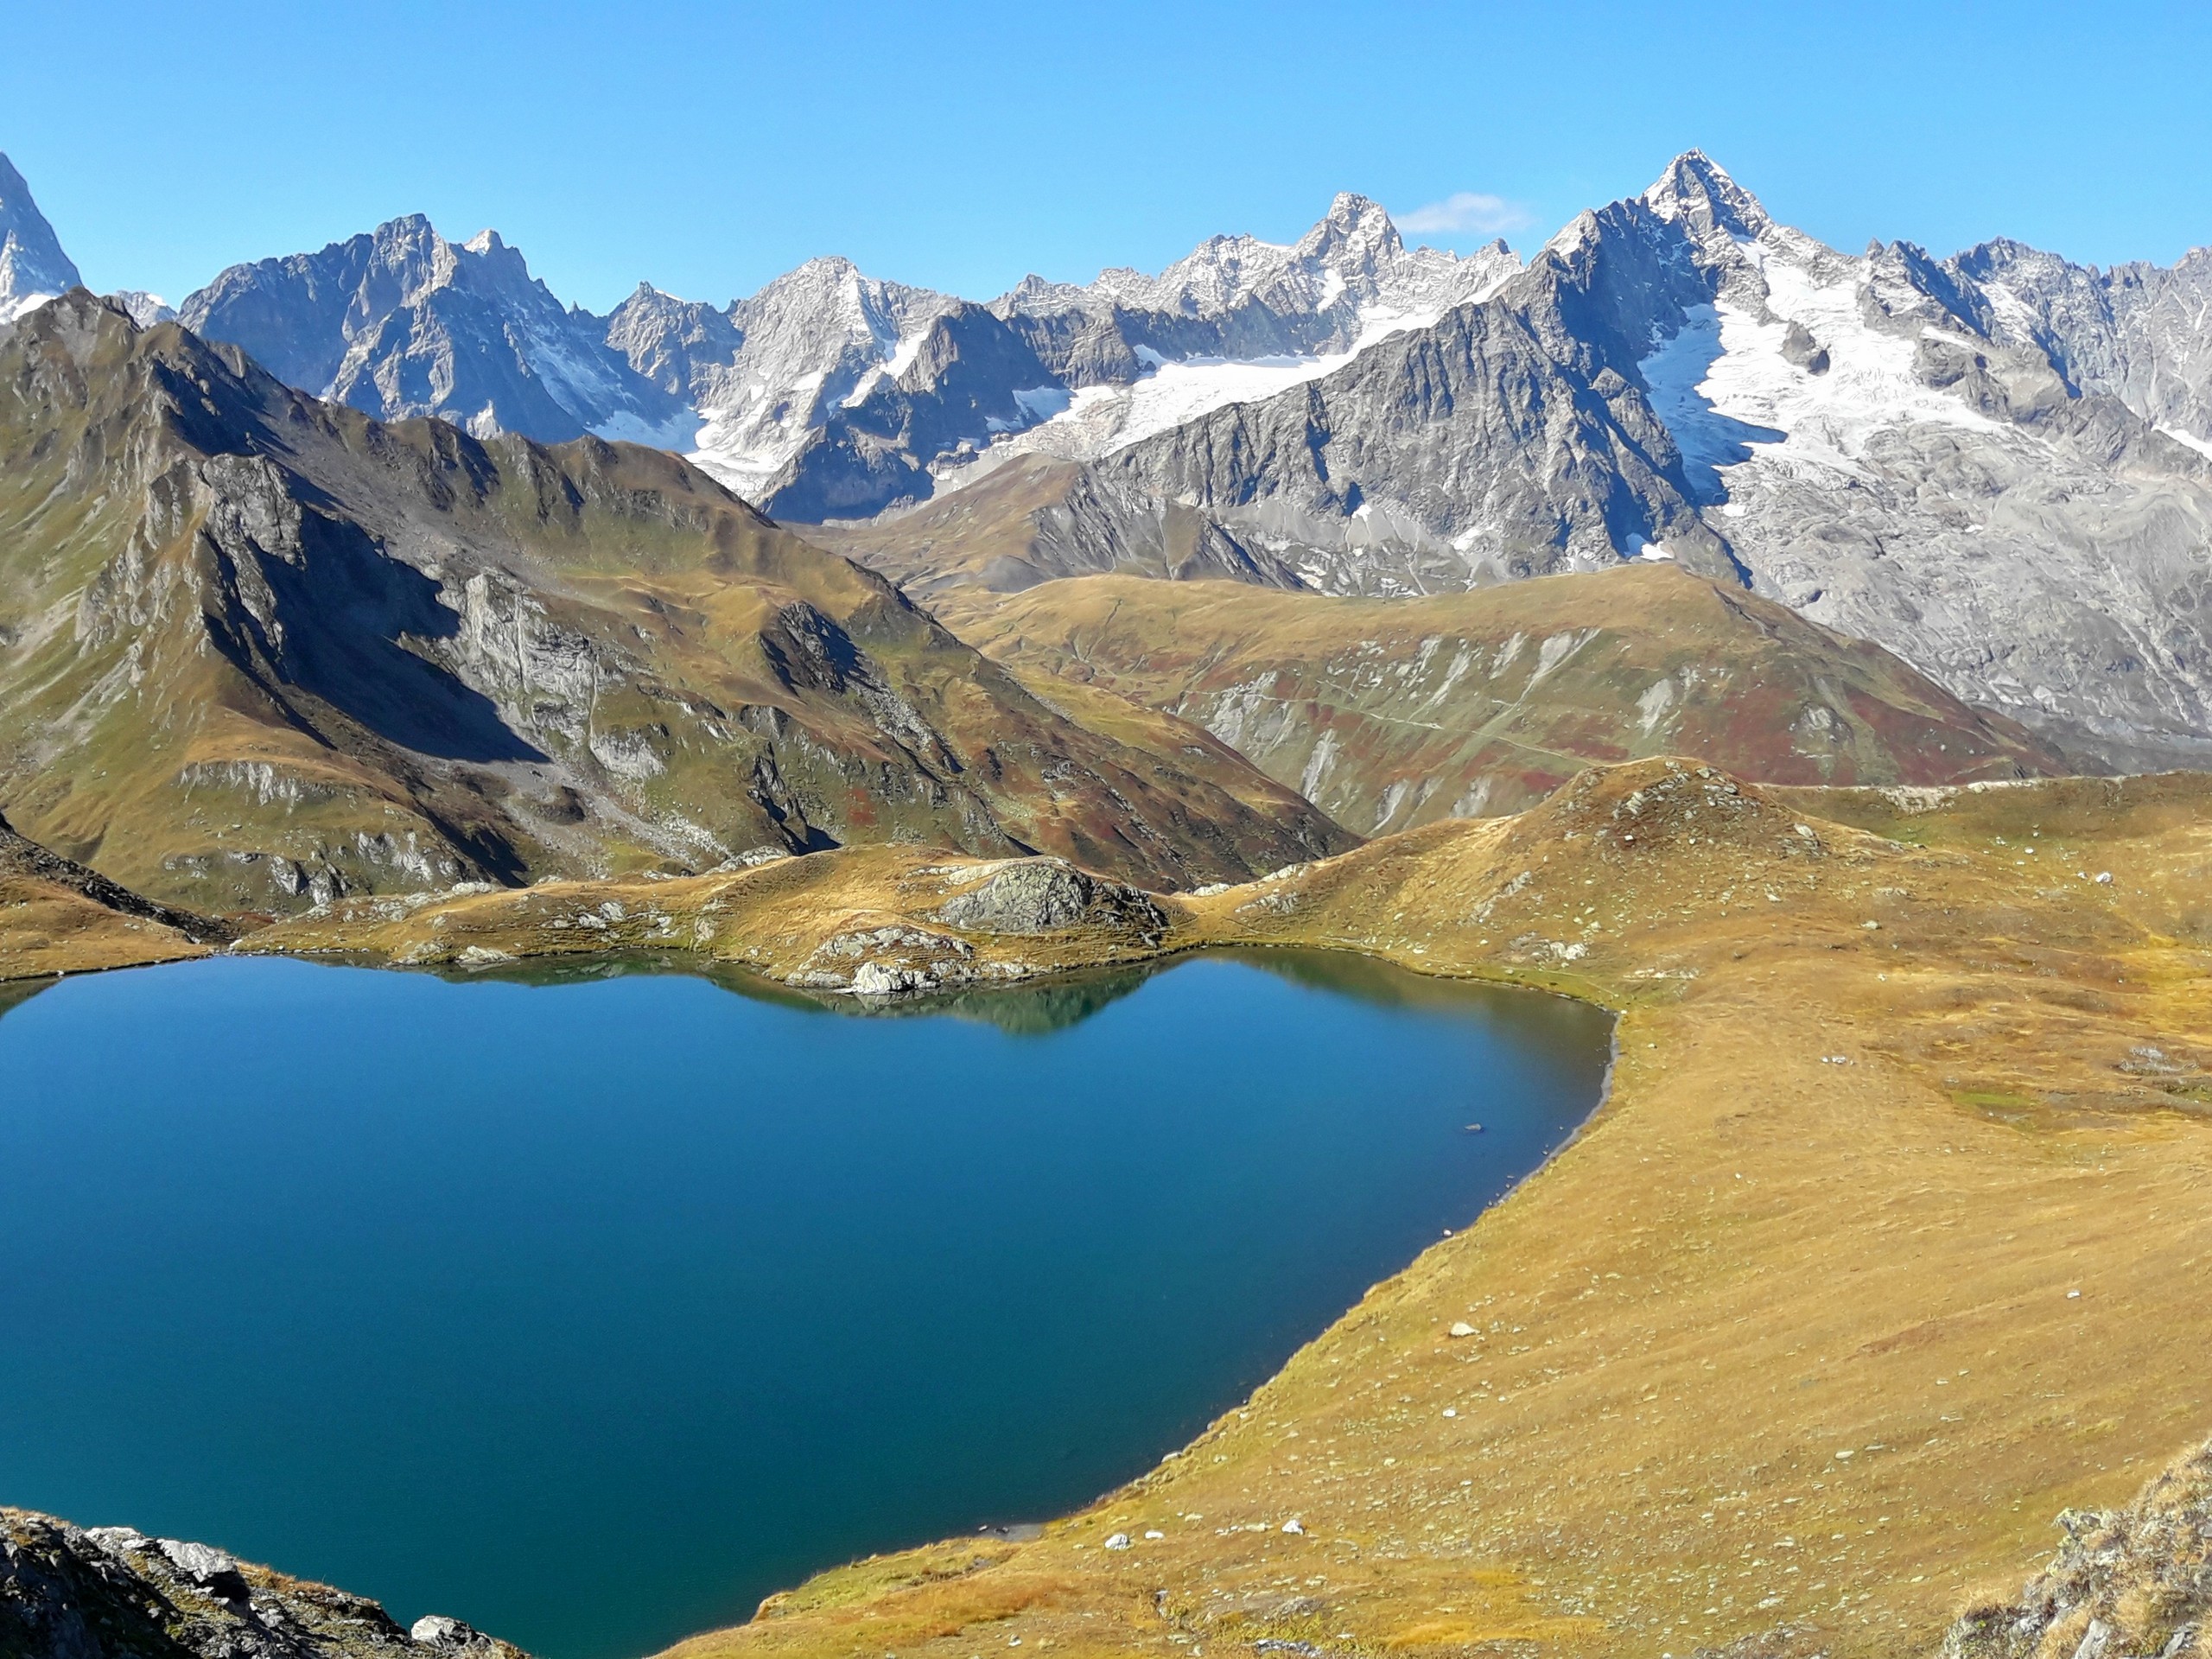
151,179,1520,522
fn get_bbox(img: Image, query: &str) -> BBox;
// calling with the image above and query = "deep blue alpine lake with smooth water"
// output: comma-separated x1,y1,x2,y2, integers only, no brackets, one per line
0,953,1608,1659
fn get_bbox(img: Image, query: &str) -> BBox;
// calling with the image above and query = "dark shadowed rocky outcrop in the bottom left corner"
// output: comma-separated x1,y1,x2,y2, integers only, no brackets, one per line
0,1509,526,1659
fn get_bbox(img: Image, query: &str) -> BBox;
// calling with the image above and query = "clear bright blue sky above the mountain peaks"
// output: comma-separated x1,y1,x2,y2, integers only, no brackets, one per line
0,0,2212,309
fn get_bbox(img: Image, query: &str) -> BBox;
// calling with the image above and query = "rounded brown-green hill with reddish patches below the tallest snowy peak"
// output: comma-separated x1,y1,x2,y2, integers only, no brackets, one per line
938,566,2069,834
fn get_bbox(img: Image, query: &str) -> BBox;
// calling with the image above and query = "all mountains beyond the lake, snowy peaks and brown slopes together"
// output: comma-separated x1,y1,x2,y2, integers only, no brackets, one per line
0,153,2212,912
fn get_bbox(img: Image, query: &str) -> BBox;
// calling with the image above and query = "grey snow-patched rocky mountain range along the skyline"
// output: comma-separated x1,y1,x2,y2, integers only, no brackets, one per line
13,150,2212,767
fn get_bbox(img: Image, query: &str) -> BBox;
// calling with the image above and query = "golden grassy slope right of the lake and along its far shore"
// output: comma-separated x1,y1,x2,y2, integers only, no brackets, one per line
186,761,2212,1659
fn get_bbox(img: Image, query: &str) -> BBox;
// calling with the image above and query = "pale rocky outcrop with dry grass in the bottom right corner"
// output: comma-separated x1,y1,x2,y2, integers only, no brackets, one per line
1942,1445,2212,1659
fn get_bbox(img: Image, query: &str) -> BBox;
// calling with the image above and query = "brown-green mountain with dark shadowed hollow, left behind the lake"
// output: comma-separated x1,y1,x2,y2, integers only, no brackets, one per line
0,289,1347,912
